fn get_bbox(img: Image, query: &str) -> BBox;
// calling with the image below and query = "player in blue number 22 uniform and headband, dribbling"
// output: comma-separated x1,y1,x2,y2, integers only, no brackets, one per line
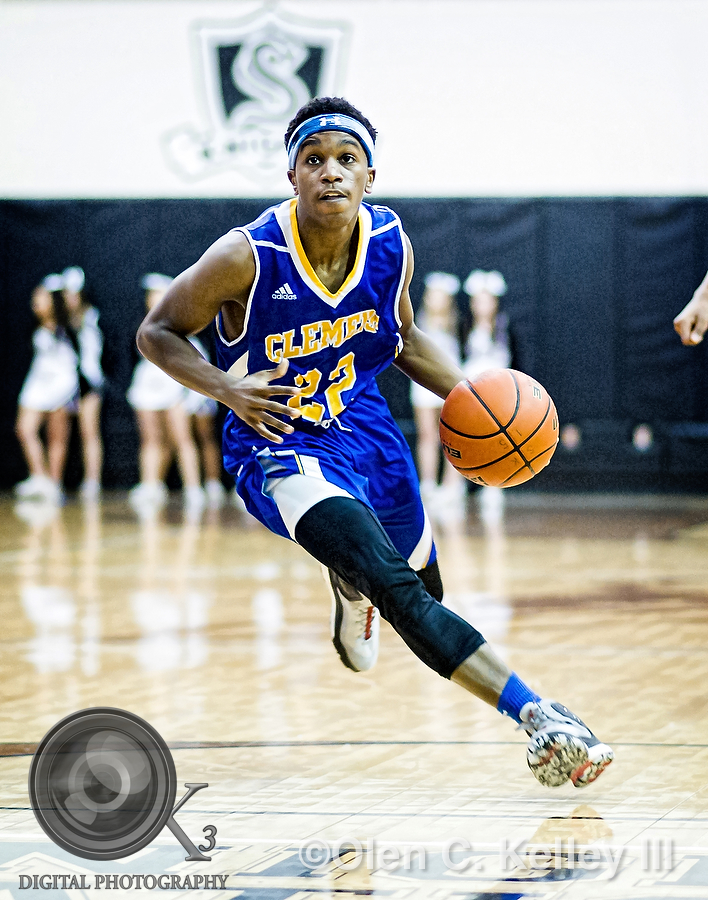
138,97,612,787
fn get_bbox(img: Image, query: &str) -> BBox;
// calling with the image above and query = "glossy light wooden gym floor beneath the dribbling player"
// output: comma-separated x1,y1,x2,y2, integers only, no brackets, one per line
0,495,708,900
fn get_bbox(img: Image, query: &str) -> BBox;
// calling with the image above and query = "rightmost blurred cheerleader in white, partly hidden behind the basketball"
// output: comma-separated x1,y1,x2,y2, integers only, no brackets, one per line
463,269,512,524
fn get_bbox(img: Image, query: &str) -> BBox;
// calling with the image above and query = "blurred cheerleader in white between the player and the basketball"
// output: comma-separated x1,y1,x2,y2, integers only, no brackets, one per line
411,272,464,519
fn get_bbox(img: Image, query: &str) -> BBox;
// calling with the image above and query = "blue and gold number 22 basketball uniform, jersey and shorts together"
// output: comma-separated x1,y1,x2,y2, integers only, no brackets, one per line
210,200,435,569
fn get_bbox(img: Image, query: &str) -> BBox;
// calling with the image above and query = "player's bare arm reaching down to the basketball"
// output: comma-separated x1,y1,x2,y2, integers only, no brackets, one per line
396,235,465,399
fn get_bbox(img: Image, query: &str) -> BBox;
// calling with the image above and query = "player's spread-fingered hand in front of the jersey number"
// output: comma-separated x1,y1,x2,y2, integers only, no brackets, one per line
224,359,302,444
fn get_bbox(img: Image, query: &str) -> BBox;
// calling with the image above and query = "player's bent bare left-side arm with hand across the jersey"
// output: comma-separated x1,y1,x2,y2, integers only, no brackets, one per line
137,232,301,443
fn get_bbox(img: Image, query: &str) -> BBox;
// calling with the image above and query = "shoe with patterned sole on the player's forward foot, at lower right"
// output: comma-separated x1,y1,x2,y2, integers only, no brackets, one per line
521,700,614,787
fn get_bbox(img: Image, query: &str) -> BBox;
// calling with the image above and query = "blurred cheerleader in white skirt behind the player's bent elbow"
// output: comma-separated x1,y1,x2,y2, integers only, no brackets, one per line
127,272,205,509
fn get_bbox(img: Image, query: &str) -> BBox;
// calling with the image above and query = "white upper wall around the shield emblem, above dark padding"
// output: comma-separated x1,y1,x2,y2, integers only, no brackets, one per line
0,0,708,197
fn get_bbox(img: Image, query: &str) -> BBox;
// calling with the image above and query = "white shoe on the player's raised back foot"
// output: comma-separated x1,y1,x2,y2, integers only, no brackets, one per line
322,566,381,672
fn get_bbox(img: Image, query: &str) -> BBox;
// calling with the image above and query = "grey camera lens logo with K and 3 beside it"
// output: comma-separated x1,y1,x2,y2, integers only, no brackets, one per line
29,707,216,860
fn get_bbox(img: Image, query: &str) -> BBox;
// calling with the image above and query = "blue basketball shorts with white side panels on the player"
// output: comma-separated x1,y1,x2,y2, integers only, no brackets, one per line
224,389,437,571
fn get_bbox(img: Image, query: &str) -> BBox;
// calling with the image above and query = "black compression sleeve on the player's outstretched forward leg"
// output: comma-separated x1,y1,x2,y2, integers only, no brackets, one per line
295,497,484,678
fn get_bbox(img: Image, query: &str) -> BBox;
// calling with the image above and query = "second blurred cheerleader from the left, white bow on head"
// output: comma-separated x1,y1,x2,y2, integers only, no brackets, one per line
62,266,105,501
